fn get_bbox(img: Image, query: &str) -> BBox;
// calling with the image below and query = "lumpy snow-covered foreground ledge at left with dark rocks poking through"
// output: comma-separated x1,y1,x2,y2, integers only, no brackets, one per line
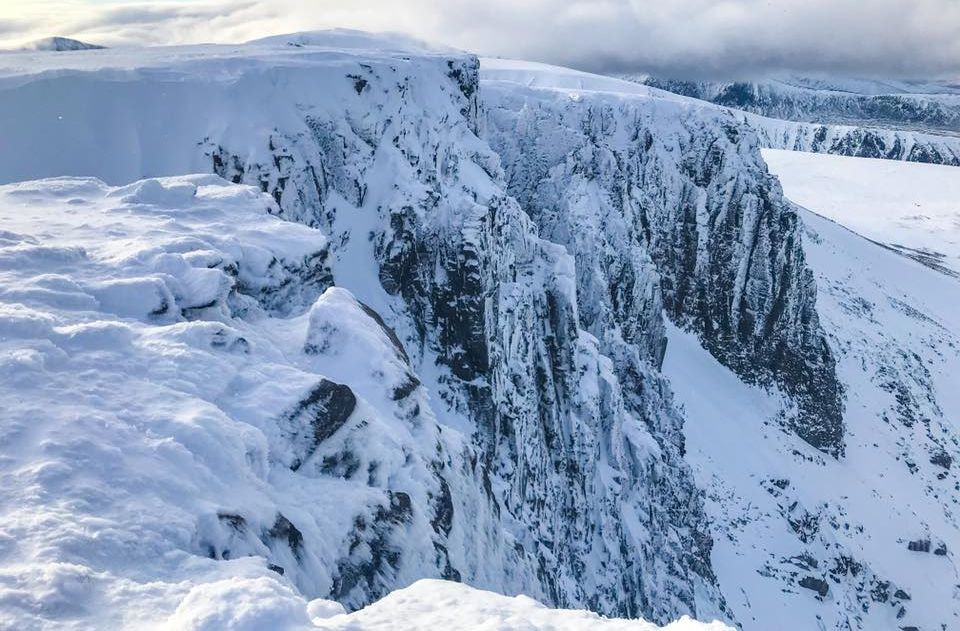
0,176,495,628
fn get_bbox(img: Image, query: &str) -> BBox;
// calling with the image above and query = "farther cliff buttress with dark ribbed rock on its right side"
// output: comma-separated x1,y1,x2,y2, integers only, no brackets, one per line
484,67,843,455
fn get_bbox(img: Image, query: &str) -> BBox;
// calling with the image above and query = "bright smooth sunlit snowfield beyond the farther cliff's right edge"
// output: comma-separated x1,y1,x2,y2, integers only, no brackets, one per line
763,149,960,274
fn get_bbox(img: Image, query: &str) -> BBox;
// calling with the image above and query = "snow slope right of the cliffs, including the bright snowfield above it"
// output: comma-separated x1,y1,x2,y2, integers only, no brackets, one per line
664,152,960,630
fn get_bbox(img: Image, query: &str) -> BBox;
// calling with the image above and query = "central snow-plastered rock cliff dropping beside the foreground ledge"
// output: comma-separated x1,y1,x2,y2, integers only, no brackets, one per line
206,48,722,618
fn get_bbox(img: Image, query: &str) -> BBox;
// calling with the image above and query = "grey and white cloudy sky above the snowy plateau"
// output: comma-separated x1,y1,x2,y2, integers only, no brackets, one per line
0,0,960,79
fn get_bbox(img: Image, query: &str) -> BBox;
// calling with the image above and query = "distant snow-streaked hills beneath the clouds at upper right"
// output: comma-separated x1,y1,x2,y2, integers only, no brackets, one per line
625,75,960,166
